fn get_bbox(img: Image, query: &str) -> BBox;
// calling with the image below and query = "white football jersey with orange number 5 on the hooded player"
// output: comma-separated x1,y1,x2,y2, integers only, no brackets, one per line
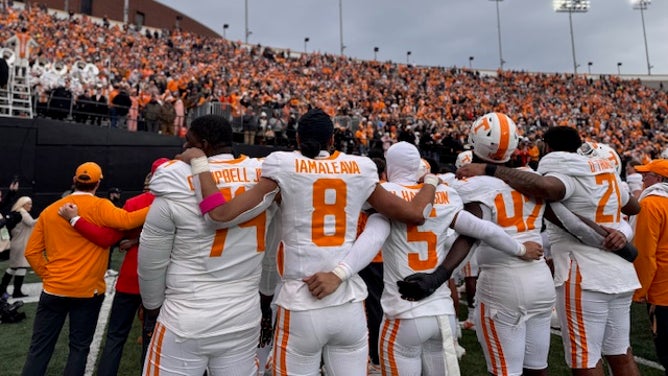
380,183,463,319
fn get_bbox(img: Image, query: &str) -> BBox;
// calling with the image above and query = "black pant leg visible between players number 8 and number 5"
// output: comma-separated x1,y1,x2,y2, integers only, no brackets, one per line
359,262,383,364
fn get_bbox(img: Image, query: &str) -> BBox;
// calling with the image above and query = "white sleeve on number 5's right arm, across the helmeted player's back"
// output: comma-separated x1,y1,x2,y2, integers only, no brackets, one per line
452,210,524,256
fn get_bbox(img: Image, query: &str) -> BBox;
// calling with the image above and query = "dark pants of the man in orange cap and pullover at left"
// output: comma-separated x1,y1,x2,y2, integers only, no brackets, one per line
22,291,104,376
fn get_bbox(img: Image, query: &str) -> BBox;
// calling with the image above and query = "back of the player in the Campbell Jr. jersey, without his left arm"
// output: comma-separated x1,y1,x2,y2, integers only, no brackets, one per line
151,155,275,335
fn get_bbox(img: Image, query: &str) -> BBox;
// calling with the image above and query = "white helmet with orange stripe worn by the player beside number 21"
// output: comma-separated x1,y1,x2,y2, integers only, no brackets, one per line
469,112,519,163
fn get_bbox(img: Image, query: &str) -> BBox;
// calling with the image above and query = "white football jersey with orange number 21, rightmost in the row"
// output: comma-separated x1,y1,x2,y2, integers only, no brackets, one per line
538,152,640,294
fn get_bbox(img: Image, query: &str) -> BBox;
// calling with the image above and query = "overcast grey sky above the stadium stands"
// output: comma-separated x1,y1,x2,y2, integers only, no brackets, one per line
159,0,668,75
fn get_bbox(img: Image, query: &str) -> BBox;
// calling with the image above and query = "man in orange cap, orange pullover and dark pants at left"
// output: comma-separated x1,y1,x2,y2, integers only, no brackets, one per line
23,162,148,375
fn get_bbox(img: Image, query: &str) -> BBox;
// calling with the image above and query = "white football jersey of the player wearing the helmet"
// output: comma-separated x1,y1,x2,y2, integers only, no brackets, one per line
457,168,545,268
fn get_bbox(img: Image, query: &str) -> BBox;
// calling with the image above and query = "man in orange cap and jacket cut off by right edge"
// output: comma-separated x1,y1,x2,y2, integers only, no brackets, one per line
632,159,668,368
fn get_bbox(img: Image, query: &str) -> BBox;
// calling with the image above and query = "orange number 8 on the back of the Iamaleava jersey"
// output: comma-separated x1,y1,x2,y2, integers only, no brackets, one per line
311,178,348,247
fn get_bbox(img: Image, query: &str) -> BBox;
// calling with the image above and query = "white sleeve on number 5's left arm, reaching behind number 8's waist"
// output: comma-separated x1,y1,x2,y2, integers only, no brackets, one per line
335,213,390,280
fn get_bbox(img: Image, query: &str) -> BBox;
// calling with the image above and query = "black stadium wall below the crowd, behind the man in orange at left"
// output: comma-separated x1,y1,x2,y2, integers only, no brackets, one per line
0,117,274,215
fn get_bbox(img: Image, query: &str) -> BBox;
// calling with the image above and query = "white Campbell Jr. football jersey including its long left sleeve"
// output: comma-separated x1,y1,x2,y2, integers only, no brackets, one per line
139,154,276,338
